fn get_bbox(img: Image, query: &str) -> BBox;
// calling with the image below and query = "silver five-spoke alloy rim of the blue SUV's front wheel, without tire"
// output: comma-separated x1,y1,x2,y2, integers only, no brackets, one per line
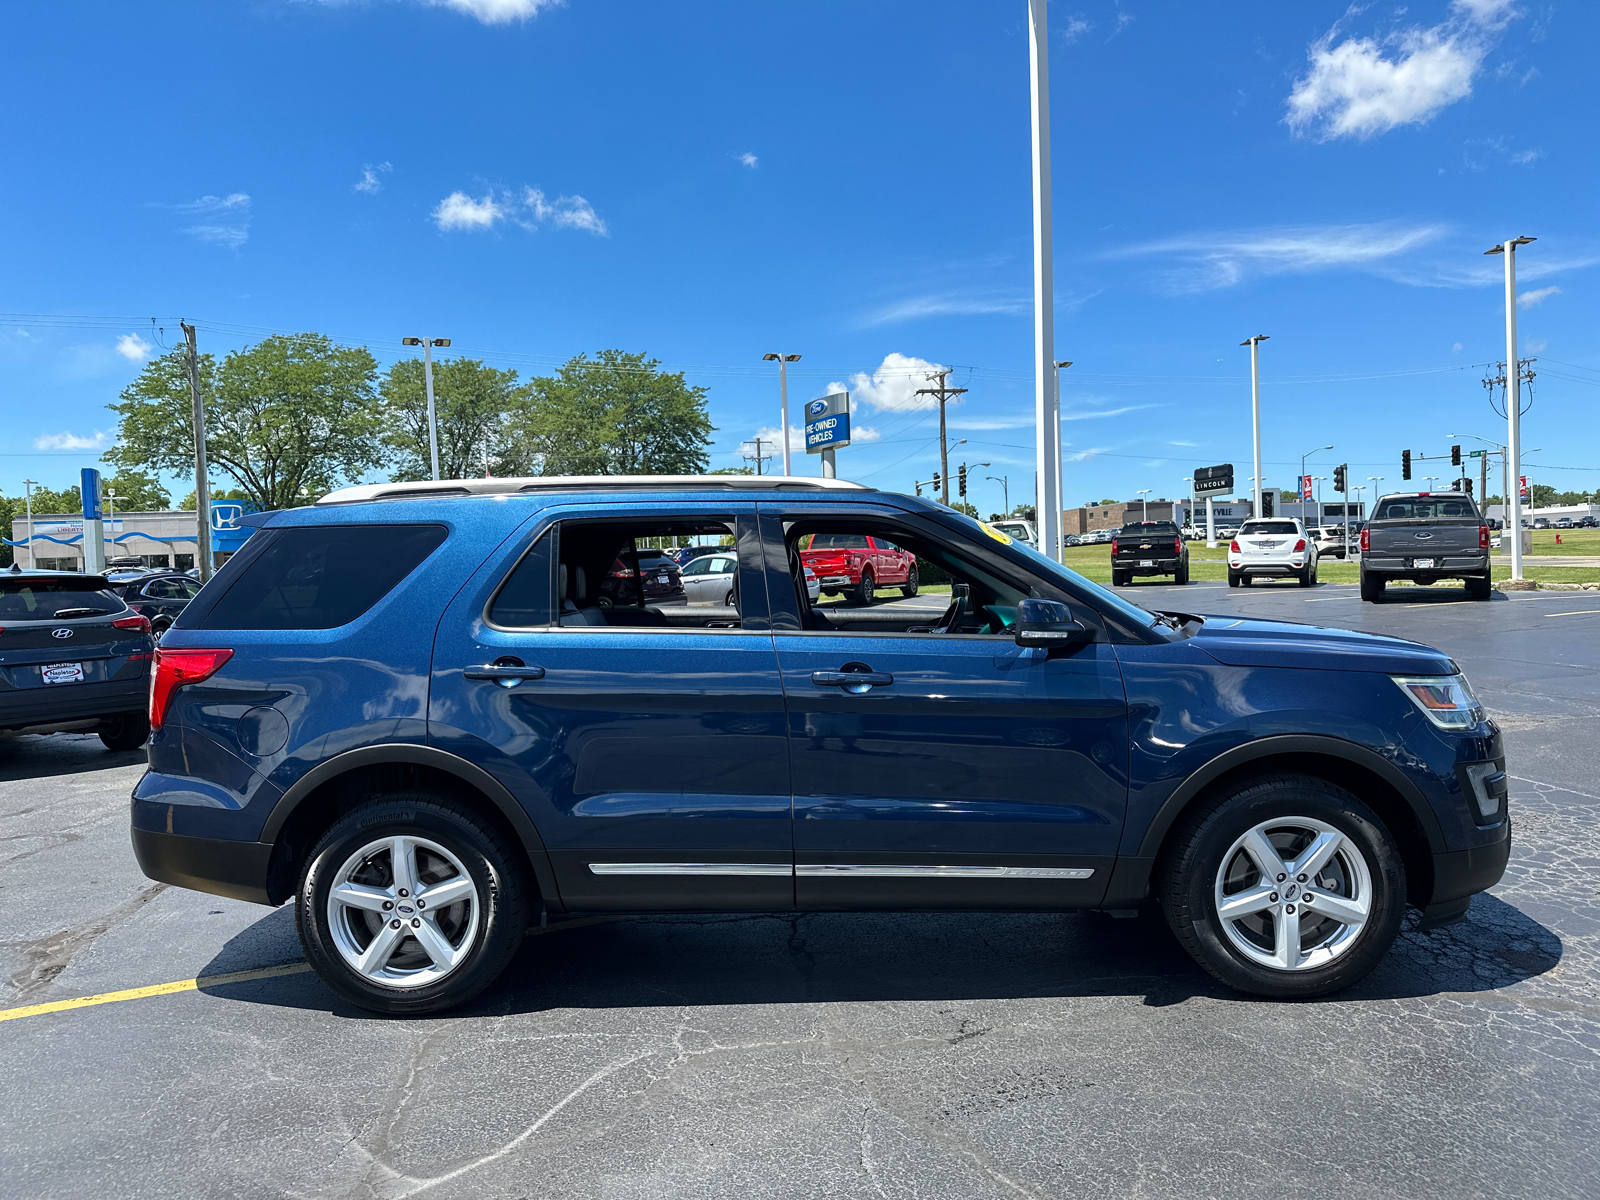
1213,816,1373,971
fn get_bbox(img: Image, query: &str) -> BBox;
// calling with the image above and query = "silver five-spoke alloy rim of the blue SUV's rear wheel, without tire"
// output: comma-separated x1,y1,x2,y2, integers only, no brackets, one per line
328,837,480,987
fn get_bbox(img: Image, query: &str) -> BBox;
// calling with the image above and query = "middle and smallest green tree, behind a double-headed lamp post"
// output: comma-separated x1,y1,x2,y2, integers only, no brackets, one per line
378,358,526,480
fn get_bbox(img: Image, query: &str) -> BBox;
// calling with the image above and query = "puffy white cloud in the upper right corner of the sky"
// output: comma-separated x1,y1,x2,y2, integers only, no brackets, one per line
1285,0,1518,141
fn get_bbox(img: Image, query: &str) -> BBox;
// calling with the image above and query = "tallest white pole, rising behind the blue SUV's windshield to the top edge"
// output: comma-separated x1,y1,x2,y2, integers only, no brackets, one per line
1027,0,1061,562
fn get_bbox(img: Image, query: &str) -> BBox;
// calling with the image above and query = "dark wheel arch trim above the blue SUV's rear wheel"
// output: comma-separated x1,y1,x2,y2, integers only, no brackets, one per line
259,742,563,910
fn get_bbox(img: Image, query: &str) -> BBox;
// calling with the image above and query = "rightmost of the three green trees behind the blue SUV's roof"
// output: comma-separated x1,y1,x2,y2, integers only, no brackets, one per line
510,350,715,475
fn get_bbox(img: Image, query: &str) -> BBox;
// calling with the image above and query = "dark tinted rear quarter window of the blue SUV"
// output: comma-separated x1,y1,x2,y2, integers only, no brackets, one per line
198,525,446,640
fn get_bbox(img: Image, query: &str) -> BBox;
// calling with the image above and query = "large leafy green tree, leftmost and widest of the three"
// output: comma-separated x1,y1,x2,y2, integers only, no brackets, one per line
106,333,384,509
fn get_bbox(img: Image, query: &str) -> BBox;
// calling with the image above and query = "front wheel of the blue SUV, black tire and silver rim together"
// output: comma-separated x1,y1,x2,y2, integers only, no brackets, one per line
1162,774,1405,998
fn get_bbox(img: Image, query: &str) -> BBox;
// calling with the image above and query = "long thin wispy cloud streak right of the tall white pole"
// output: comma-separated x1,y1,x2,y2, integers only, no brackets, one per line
1107,224,1445,291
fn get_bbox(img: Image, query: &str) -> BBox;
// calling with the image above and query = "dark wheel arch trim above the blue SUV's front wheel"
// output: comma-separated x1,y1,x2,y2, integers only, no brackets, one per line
1139,734,1445,904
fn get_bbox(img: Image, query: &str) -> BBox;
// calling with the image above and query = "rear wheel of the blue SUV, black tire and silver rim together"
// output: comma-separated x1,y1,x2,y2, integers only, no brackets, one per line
294,792,528,1014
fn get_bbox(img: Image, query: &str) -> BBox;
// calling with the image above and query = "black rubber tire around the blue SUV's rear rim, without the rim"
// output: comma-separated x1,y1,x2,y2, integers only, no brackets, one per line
294,790,531,1016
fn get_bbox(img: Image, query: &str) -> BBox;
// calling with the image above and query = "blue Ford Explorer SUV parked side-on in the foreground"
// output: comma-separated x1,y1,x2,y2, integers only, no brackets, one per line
133,477,1510,1013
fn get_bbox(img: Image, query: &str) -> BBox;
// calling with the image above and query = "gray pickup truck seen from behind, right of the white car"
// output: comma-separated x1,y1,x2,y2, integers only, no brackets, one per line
1362,491,1490,600
